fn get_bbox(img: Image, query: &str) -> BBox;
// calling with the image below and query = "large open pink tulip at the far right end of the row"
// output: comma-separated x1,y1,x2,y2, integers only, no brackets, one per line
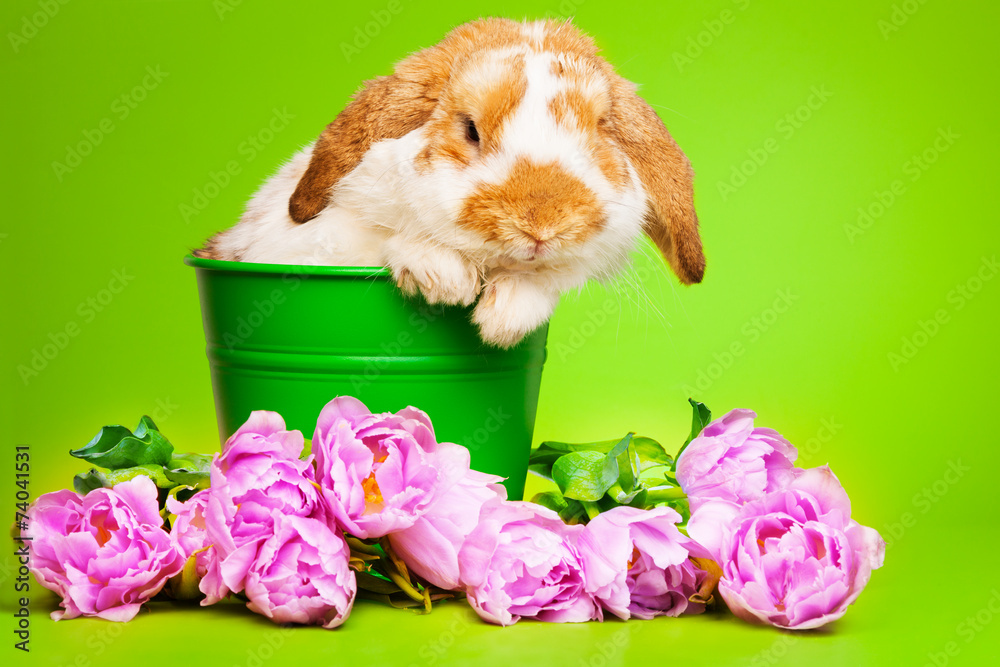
688,466,885,630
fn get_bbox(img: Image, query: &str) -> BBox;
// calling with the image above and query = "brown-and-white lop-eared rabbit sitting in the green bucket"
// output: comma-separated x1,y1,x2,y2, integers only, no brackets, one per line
197,18,705,348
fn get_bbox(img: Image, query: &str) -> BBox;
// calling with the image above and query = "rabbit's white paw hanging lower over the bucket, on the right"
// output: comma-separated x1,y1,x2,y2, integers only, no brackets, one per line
472,274,559,347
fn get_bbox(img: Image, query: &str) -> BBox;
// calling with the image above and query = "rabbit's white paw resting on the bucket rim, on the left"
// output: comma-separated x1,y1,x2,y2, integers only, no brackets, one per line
389,247,482,306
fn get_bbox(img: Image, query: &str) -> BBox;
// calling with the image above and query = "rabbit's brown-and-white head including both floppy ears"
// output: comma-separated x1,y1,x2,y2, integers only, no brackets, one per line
289,19,705,283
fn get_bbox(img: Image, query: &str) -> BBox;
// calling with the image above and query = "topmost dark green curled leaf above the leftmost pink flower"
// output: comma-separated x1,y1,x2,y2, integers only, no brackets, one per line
70,415,174,470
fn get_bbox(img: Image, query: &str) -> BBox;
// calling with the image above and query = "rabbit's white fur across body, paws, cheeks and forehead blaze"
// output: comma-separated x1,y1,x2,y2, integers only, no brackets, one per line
208,25,646,346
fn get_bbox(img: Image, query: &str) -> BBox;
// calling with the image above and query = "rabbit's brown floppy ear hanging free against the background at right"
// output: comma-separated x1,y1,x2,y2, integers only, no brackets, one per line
611,77,705,285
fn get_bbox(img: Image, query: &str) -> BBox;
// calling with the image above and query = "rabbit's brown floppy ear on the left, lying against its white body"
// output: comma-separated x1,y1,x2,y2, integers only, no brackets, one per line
288,74,437,222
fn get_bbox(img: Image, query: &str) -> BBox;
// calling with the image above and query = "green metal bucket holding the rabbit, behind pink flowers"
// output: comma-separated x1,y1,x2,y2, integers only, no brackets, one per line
184,255,547,499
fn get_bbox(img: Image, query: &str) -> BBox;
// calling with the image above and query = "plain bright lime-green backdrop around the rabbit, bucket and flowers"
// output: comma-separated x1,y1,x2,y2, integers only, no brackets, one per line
0,0,1000,667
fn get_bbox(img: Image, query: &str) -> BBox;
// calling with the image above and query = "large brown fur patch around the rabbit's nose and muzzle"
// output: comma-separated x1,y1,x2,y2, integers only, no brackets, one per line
459,158,604,253
